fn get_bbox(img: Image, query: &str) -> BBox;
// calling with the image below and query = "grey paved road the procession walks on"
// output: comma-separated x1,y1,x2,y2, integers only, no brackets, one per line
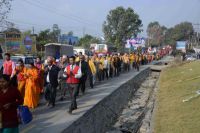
20,66,148,133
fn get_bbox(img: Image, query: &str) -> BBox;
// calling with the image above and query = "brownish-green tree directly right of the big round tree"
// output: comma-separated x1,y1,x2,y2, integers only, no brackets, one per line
147,21,167,46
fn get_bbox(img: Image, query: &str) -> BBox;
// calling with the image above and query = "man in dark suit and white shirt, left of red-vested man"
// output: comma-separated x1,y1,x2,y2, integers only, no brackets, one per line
44,57,59,107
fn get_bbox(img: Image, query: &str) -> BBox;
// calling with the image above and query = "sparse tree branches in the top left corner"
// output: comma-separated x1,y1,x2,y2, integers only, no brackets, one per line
0,0,13,28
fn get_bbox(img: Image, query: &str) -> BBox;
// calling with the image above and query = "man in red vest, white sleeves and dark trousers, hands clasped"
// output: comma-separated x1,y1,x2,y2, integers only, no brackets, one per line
65,56,82,114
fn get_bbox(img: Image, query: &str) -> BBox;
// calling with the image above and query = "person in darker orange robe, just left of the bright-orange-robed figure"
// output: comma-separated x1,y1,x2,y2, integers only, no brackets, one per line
14,59,26,98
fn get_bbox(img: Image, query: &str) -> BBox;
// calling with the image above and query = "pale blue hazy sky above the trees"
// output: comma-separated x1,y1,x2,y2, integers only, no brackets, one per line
8,0,200,37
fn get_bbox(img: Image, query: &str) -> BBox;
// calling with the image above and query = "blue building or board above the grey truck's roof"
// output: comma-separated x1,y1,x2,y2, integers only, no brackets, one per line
58,34,79,45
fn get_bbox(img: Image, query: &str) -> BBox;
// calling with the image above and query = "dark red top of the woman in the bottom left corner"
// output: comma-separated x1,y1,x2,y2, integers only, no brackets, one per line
0,87,23,128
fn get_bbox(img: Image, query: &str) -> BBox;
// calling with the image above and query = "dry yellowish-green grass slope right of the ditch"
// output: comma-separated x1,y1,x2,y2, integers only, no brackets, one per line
154,61,200,133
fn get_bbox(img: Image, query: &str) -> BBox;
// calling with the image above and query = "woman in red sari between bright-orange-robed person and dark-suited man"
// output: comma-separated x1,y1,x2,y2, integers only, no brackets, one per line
35,57,44,93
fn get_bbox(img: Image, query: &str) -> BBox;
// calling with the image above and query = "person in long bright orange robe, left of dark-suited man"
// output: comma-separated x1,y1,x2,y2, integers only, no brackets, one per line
24,63,40,108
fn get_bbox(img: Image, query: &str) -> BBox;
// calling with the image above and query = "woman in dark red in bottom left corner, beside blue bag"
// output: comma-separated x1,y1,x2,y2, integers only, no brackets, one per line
0,76,23,133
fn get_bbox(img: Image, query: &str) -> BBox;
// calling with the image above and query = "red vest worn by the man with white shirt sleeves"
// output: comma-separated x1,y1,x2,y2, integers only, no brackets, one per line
67,65,79,84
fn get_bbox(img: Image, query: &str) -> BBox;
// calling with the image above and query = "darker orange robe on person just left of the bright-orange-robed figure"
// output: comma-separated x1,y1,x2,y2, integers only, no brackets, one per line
15,67,27,98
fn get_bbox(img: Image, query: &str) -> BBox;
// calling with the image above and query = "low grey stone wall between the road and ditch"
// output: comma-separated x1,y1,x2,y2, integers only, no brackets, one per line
63,68,151,133
